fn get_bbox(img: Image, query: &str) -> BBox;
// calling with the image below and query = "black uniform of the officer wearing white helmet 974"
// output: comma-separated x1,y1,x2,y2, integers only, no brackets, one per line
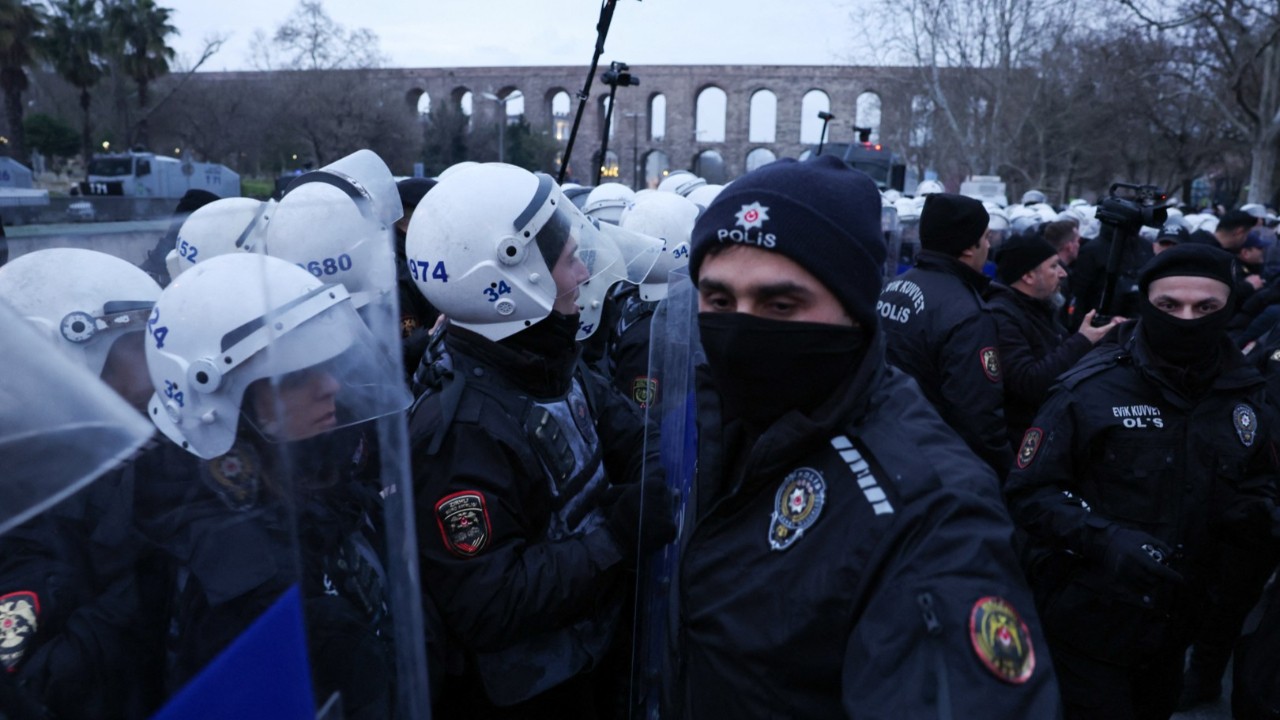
410,322,644,717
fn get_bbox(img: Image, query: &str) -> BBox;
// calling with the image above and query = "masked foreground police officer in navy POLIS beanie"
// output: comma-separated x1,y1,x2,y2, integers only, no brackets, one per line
667,155,1057,719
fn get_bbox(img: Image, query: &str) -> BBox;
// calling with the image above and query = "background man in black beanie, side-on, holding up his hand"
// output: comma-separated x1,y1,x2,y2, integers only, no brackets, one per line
989,234,1124,446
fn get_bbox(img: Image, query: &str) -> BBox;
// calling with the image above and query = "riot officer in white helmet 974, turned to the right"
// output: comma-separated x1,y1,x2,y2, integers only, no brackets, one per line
407,164,672,717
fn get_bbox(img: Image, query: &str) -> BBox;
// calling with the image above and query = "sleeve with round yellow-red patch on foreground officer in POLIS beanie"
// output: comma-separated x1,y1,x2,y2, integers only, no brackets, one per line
842,484,1060,720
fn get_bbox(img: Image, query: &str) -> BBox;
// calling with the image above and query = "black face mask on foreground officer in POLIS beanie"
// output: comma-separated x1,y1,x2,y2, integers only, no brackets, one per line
698,313,867,427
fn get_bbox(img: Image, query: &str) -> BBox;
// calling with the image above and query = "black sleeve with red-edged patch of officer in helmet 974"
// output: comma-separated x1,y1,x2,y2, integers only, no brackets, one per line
413,424,622,651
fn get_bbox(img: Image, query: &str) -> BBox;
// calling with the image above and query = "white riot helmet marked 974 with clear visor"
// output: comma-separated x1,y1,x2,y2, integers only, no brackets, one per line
404,163,662,341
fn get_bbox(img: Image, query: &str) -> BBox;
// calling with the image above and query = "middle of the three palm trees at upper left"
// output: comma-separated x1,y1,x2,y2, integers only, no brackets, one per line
45,0,106,165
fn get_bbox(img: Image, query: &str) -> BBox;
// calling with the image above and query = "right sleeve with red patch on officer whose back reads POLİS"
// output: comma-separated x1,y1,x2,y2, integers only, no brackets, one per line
937,311,1012,478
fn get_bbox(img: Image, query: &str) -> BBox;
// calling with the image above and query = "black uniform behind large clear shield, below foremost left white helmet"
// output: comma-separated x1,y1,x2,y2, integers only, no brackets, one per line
128,425,394,719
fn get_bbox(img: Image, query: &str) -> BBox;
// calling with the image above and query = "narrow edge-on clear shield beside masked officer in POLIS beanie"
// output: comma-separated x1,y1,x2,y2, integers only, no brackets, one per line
628,268,701,719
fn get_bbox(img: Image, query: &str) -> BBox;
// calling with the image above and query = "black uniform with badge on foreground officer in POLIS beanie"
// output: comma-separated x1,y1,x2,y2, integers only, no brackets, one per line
668,340,1059,719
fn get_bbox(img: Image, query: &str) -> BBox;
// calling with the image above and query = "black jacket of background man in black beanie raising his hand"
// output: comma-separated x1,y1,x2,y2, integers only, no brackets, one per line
987,283,1093,447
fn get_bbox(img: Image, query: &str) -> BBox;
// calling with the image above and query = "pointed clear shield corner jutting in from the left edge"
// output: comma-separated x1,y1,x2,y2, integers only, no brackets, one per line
0,294,154,535
